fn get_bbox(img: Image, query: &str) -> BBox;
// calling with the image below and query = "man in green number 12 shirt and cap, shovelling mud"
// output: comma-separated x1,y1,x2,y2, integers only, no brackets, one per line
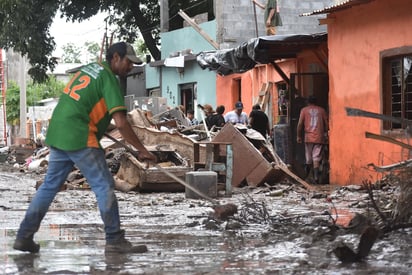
13,42,156,253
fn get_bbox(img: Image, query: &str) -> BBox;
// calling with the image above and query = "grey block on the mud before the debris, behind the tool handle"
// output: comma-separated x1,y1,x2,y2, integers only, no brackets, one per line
185,171,217,199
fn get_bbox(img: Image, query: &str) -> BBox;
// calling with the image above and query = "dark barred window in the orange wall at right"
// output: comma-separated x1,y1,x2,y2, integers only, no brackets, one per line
382,47,412,130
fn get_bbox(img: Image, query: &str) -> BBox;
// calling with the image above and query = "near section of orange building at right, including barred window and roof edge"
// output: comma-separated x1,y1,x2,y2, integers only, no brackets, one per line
312,0,412,185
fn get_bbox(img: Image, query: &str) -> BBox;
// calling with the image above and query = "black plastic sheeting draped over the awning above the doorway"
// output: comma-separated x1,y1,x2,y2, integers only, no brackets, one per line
196,32,327,75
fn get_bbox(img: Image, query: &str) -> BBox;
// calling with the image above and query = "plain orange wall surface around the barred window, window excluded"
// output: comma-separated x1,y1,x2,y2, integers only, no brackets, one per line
328,0,412,188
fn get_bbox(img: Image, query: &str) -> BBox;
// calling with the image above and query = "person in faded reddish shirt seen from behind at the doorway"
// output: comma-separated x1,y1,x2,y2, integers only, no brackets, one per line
296,96,328,184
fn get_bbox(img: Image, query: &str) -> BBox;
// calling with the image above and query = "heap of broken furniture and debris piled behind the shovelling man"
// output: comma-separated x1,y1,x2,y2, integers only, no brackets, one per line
2,109,312,192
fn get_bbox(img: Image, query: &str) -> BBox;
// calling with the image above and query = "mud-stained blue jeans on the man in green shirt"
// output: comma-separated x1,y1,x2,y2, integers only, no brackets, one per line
17,148,124,242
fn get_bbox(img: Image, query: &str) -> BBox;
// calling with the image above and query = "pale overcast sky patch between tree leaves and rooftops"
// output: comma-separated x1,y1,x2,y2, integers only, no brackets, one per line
50,13,110,57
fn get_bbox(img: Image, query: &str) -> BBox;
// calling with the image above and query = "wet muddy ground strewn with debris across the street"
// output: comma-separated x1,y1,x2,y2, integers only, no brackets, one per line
0,167,412,274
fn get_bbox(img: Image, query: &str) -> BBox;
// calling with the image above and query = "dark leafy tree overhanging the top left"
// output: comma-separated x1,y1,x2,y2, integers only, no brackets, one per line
0,0,213,82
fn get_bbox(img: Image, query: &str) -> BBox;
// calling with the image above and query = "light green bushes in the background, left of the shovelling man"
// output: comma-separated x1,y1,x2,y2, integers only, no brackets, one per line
6,76,65,125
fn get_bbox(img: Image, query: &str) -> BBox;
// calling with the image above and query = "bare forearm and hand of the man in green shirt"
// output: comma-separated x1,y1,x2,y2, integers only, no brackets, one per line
112,111,157,162
